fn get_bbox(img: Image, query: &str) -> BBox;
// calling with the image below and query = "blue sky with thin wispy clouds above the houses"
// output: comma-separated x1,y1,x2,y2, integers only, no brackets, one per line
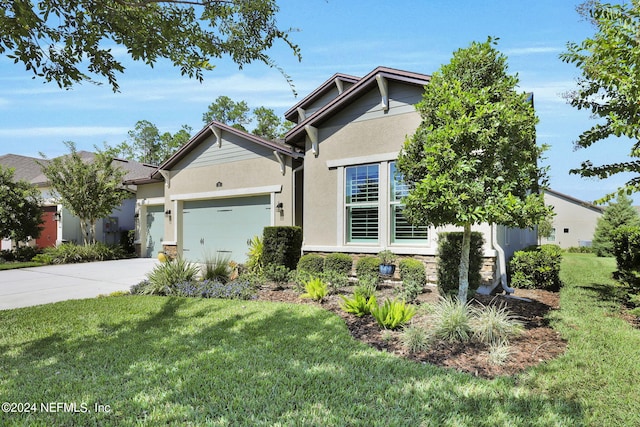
0,0,640,206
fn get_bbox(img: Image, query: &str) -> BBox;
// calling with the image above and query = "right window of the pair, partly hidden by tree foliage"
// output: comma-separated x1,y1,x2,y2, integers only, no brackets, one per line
389,162,429,243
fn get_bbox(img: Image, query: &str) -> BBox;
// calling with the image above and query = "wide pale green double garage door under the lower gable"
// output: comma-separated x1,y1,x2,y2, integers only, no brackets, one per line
182,195,271,262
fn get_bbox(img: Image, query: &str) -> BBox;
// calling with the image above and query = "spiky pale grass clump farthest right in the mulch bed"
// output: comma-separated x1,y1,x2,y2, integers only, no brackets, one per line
471,304,524,344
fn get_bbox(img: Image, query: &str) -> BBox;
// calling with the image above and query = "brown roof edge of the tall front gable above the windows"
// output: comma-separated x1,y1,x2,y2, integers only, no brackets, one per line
285,67,431,145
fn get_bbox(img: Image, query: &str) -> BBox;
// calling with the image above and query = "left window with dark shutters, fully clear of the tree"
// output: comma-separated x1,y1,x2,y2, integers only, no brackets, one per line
345,164,380,243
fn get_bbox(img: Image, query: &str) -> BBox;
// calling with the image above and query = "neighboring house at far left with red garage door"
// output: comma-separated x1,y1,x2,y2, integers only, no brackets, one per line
0,151,156,249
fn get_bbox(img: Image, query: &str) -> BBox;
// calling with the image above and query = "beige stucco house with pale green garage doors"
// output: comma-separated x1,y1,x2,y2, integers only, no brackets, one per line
131,67,537,286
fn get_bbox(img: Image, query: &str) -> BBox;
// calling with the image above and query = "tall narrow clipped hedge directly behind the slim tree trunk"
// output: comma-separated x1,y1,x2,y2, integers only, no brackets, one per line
437,231,484,296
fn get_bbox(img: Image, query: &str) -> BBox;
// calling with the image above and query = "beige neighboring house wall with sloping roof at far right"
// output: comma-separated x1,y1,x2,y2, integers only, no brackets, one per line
540,189,604,249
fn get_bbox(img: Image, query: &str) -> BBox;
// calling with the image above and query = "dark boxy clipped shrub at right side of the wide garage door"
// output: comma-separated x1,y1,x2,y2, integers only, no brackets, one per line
262,226,302,270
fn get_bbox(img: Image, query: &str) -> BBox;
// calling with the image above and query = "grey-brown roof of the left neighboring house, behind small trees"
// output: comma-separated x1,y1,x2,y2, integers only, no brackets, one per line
0,151,157,187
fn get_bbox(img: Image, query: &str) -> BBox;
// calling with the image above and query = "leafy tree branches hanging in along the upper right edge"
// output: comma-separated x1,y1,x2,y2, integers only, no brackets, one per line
560,0,640,202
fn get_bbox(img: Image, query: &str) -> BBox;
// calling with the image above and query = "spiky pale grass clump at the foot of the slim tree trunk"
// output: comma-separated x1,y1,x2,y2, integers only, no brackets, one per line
433,297,473,342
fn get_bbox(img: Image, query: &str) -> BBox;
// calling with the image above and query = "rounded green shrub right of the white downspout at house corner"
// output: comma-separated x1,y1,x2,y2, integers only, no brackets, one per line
509,245,562,291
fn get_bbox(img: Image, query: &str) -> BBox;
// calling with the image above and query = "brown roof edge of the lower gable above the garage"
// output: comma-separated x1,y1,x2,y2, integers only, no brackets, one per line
146,120,304,180
